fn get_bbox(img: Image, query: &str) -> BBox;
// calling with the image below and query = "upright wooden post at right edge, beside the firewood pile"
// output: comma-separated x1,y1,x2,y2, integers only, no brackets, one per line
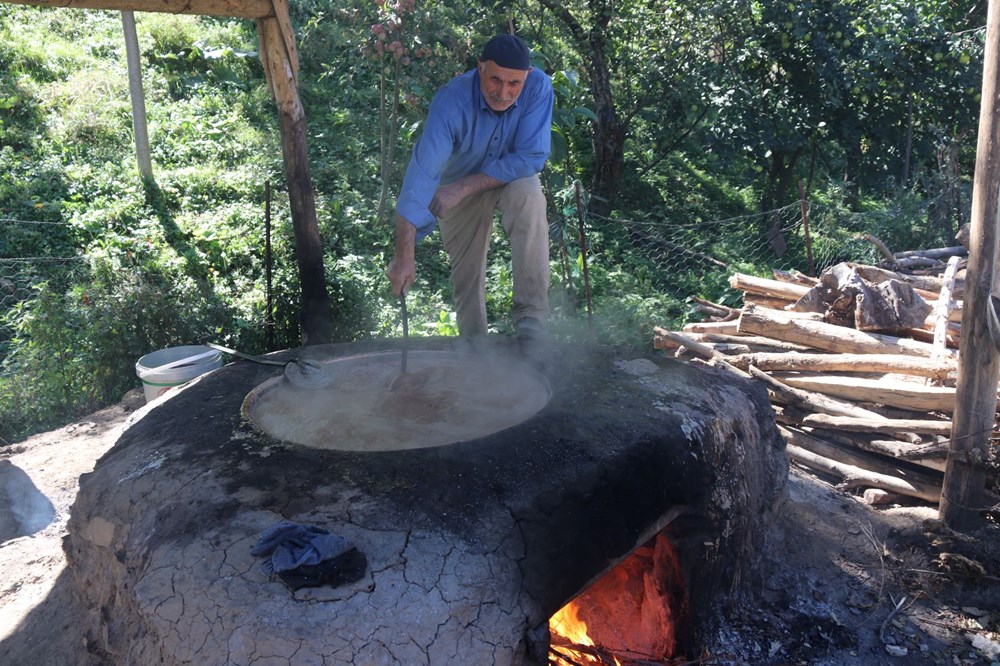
939,0,1000,530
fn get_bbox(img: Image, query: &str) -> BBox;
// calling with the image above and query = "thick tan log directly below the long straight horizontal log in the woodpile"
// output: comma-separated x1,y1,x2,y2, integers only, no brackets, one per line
774,372,955,414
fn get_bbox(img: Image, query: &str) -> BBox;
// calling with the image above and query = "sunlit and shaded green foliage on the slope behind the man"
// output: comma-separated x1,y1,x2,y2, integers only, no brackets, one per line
0,0,984,440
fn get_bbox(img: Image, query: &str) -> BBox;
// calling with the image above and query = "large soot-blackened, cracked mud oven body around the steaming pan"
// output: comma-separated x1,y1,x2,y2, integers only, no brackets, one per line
65,339,787,664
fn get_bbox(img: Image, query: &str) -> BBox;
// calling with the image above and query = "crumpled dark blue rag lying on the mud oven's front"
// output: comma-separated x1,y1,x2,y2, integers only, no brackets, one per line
250,520,354,574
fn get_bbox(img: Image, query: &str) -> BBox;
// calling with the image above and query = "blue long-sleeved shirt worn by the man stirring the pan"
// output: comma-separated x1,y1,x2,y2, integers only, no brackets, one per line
396,69,555,240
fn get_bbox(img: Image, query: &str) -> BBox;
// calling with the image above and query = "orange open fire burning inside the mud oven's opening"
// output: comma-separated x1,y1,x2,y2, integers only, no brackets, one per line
549,532,687,666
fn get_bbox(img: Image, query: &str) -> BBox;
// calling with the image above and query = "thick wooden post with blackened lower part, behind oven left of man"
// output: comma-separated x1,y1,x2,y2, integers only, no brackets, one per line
257,0,332,345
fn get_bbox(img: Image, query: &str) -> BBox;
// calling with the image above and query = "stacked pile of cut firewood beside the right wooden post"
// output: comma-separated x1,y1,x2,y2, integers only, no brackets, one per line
654,236,984,504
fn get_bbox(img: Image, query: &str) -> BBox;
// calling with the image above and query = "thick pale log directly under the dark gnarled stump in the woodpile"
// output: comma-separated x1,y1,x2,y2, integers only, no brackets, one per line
737,307,956,358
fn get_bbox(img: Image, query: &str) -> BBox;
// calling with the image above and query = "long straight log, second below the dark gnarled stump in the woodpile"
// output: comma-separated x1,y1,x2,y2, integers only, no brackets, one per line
729,348,958,381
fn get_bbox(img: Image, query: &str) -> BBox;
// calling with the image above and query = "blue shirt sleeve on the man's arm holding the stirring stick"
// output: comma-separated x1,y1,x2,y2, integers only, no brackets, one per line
396,84,464,240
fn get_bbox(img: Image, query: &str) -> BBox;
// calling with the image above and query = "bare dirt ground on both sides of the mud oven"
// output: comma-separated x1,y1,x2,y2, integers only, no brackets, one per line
0,391,1000,666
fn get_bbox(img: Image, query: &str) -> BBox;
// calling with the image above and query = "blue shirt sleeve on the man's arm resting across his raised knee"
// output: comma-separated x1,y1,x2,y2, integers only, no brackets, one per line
482,69,555,183
